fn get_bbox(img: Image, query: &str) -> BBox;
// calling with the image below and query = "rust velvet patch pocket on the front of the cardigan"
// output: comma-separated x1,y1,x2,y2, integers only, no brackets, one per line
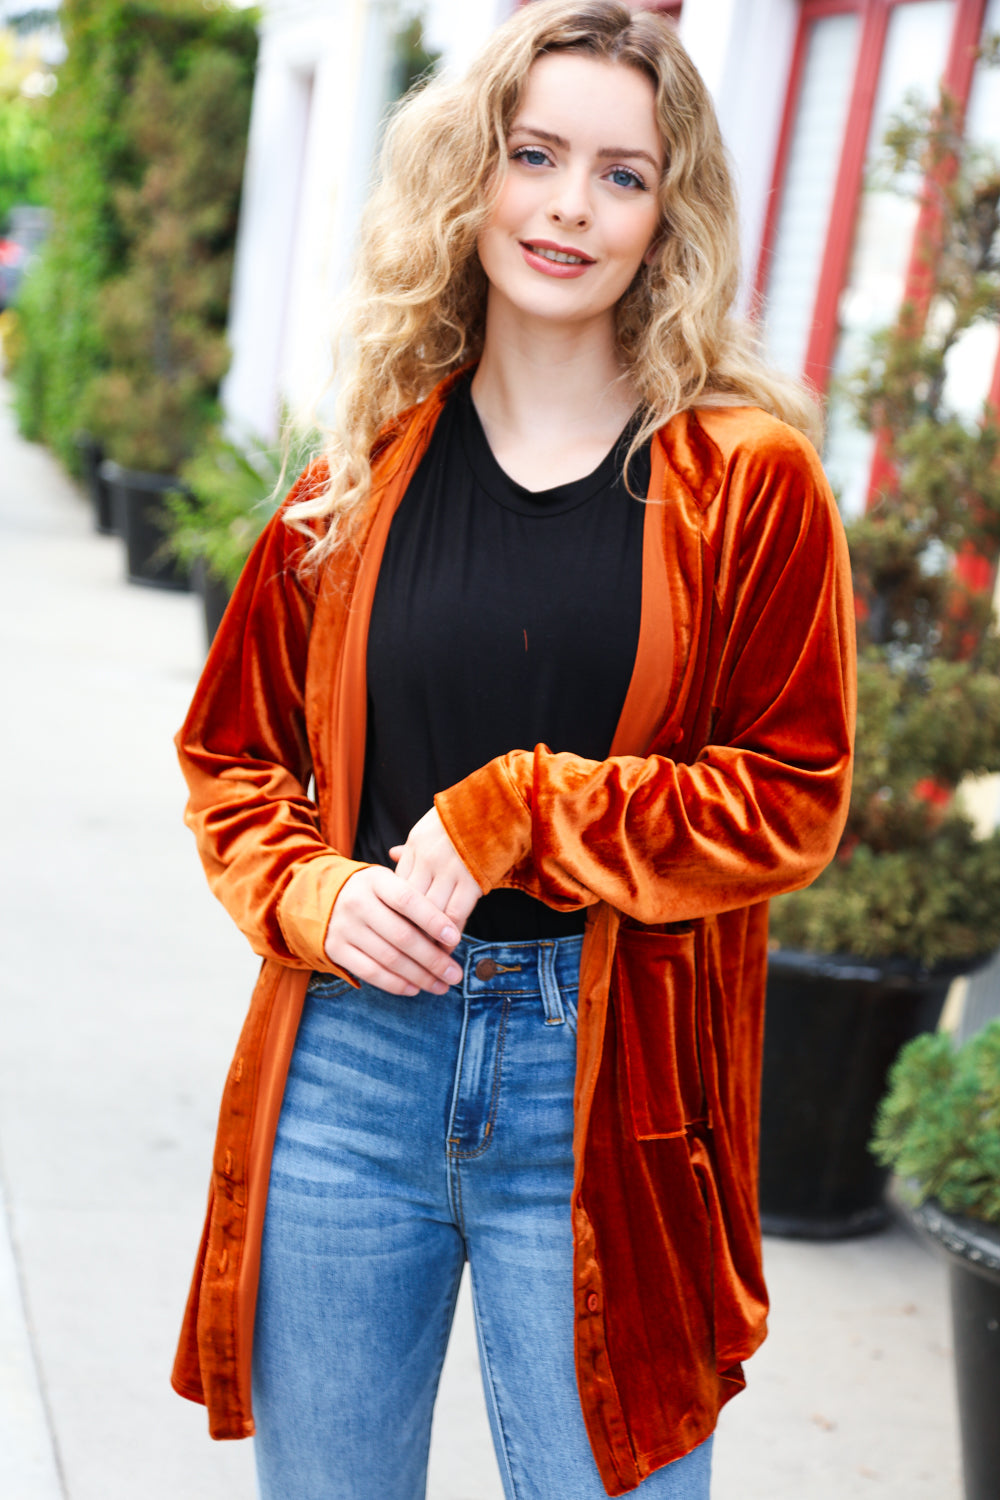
613,927,708,1140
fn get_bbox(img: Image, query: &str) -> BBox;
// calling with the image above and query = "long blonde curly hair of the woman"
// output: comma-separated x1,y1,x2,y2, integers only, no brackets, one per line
285,0,820,564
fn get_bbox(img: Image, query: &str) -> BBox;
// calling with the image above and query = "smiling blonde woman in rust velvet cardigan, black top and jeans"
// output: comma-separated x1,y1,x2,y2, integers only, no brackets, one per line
167,0,853,1500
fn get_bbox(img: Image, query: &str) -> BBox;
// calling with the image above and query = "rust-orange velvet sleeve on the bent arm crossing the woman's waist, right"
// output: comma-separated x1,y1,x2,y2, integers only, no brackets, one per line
435,440,856,924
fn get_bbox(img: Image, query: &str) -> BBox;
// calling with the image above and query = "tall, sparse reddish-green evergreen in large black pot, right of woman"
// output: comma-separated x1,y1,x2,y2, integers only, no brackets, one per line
760,87,1000,1236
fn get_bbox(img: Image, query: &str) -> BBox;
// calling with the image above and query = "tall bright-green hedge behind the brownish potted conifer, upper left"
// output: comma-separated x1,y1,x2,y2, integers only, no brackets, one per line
13,0,256,467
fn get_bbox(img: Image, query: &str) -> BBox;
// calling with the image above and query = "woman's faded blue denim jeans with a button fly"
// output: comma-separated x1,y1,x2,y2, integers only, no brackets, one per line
253,938,712,1500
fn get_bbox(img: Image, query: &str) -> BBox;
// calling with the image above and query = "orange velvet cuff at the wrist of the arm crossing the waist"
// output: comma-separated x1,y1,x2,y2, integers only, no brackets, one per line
435,750,532,891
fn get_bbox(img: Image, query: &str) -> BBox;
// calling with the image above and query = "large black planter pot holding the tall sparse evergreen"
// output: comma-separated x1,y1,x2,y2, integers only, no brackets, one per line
760,950,959,1236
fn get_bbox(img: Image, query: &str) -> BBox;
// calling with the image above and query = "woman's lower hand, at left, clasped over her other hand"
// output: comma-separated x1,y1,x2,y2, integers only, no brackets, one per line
324,864,462,995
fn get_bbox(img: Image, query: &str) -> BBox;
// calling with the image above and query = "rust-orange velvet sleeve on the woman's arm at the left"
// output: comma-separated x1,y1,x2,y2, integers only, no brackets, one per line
175,470,370,974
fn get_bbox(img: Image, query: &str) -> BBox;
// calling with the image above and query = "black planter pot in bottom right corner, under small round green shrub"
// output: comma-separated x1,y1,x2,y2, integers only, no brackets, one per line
897,1196,1000,1500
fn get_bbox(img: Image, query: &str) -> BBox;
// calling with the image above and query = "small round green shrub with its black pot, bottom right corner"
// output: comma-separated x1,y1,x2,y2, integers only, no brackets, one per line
871,1020,1000,1500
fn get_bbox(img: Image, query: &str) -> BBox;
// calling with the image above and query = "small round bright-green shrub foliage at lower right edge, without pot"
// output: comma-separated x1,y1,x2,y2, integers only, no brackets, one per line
871,1020,1000,1224
